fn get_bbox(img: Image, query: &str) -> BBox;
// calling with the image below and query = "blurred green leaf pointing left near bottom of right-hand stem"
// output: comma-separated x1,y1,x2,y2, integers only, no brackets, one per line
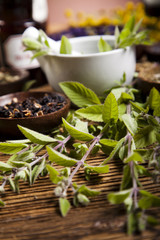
108,189,132,204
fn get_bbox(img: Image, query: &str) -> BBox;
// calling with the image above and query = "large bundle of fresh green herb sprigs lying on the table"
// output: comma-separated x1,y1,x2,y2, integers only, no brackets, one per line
0,79,160,234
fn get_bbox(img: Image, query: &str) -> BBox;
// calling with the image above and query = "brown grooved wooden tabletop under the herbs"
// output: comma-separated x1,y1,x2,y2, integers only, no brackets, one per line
0,86,160,240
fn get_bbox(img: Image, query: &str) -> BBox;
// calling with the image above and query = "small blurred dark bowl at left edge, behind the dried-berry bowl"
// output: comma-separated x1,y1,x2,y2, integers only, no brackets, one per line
0,67,29,96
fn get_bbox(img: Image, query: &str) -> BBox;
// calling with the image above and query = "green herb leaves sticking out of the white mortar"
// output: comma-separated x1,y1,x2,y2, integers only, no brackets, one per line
23,16,150,59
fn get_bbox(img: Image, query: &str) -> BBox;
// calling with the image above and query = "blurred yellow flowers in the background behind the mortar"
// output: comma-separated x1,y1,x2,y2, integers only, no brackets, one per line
65,1,160,41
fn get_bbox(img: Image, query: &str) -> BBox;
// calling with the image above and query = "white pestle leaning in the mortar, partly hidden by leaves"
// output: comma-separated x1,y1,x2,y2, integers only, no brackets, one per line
22,27,81,56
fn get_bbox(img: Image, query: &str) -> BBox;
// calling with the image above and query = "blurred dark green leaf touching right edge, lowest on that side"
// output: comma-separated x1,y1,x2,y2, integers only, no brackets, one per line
138,190,160,209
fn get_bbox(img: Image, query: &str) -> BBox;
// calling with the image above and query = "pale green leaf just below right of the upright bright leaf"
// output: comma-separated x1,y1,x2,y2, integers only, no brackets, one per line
122,114,138,136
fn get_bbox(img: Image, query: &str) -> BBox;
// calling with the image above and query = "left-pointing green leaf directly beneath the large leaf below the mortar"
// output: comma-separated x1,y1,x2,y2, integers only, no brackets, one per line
76,105,103,122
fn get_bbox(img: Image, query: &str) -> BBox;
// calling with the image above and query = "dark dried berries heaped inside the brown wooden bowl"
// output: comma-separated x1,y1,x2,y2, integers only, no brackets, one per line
0,94,66,118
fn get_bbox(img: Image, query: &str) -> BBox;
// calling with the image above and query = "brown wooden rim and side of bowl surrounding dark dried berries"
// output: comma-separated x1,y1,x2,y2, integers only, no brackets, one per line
0,92,70,139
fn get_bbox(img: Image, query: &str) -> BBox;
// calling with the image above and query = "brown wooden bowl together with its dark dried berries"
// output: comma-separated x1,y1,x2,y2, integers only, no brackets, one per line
0,92,70,140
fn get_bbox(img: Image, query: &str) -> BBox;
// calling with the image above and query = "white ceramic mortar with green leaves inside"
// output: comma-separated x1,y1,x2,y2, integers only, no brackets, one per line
38,35,136,95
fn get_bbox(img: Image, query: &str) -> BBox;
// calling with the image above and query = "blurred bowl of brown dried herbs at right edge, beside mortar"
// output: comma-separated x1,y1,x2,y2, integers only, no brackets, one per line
137,62,160,95
